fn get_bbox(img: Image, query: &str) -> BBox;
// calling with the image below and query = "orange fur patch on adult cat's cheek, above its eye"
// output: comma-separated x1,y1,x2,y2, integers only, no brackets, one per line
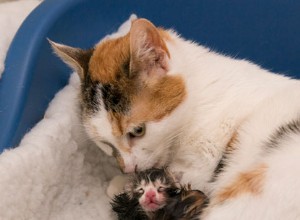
108,76,186,140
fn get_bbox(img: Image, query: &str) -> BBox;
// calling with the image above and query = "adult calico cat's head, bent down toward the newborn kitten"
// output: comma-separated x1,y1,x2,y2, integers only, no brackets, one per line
50,19,186,172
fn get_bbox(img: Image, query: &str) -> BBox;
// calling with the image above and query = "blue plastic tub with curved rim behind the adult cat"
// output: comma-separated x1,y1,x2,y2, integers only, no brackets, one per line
0,0,300,152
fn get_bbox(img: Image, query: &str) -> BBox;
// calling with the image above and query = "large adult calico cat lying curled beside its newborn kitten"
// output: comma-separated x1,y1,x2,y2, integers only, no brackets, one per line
51,19,300,220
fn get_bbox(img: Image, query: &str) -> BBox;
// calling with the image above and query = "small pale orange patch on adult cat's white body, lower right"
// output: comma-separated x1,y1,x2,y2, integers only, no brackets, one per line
217,165,267,203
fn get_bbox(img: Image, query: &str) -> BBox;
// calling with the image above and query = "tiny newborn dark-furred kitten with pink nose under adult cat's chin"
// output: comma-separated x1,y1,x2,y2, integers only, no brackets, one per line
111,168,208,220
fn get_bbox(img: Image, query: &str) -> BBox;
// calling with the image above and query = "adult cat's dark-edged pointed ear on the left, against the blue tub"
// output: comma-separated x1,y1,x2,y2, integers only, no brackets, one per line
48,39,92,80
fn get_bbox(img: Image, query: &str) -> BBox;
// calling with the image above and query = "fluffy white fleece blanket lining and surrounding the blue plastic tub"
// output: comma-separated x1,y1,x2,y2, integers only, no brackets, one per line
0,0,133,220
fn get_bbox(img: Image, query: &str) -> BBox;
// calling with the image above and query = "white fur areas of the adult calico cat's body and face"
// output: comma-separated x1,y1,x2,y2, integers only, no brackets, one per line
82,22,300,220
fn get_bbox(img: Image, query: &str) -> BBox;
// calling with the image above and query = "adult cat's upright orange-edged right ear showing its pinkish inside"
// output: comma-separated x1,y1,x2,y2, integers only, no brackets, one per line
130,19,170,76
